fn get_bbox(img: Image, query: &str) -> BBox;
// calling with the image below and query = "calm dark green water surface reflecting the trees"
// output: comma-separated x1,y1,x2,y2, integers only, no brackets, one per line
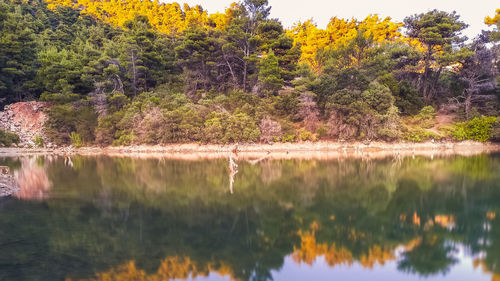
0,154,500,281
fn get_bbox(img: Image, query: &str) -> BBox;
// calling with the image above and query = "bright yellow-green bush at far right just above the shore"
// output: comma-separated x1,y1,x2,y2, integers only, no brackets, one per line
453,117,497,142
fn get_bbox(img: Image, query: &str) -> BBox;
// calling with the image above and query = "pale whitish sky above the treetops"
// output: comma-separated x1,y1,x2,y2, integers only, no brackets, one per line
180,0,500,38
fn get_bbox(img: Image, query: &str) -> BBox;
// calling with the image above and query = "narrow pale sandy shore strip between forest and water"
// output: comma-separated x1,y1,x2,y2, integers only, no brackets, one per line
0,141,500,160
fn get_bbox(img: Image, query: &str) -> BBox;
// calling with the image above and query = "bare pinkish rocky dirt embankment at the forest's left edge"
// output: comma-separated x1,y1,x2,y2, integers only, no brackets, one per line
0,101,50,147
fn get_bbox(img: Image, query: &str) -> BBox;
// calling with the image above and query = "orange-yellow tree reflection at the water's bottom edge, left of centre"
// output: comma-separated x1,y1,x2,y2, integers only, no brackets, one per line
66,257,235,281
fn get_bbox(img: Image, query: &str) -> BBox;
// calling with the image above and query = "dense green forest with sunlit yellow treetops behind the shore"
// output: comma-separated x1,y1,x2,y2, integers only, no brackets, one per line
0,0,500,144
